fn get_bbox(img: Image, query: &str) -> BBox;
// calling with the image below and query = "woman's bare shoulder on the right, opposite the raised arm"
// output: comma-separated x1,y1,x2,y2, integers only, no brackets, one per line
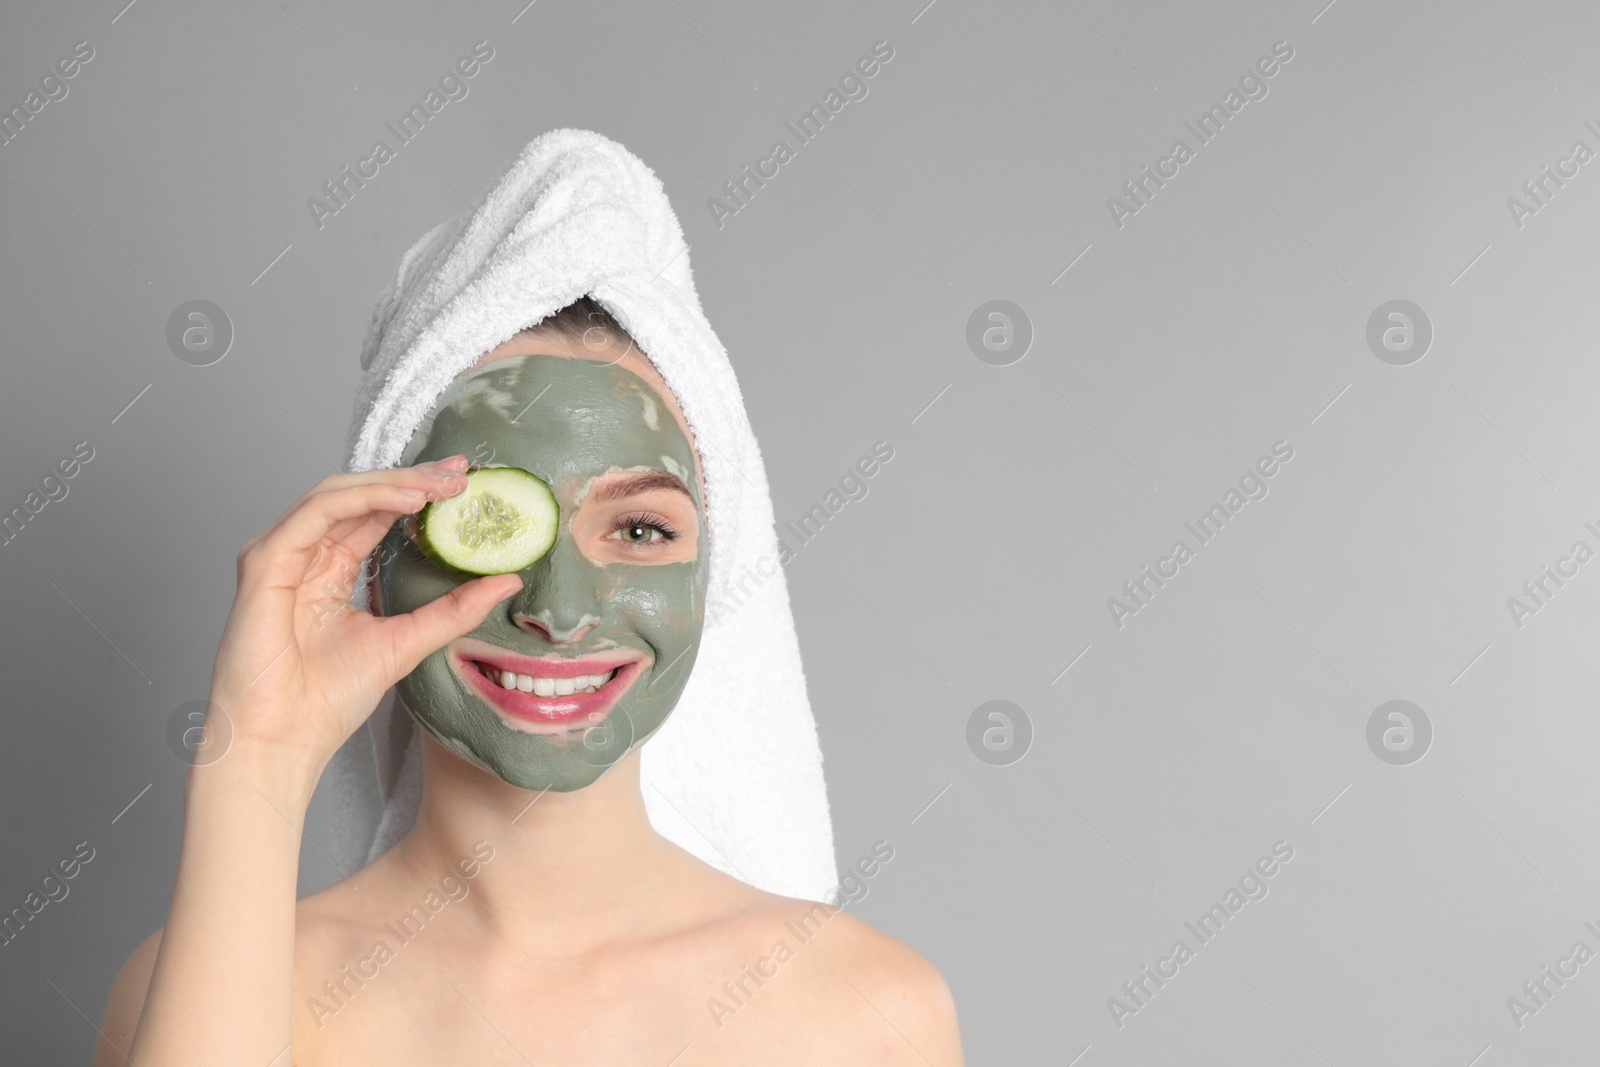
723,894,963,1067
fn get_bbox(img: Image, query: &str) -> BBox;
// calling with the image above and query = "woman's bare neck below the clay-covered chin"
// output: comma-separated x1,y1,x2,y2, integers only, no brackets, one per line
392,731,686,952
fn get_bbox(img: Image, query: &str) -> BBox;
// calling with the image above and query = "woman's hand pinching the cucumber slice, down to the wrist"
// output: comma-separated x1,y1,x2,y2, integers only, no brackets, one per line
208,456,522,781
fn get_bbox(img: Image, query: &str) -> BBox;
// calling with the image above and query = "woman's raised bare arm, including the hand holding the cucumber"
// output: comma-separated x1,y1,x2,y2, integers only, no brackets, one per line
94,456,522,1067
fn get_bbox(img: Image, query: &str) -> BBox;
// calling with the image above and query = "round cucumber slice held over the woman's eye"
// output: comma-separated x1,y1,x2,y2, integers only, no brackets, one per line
416,467,562,574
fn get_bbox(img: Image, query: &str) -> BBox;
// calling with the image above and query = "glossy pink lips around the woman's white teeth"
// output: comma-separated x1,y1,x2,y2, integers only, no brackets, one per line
450,641,643,734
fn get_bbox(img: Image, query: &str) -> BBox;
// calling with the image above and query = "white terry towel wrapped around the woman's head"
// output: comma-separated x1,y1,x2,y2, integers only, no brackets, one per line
315,130,837,901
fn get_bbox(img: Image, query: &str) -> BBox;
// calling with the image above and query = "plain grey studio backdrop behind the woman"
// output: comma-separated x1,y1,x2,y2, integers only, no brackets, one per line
0,0,1600,1067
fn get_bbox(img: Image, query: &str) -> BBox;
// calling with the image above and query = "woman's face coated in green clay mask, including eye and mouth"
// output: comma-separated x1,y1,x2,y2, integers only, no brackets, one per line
378,355,709,792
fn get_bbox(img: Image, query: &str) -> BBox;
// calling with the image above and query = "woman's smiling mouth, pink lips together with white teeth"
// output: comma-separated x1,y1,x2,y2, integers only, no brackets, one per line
450,649,645,734
